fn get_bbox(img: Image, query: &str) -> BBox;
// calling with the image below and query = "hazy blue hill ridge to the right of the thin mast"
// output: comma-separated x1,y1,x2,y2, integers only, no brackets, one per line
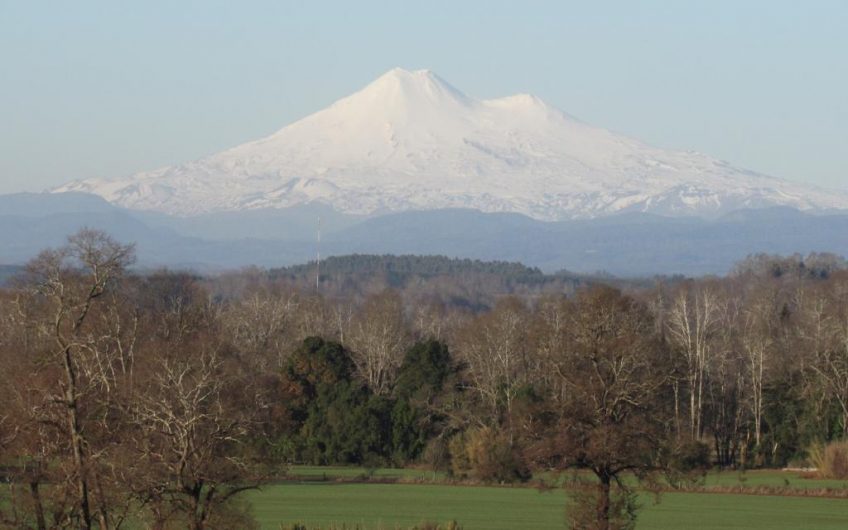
316,208,848,276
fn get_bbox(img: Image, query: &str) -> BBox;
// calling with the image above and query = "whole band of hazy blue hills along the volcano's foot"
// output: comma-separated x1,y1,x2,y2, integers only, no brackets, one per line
0,194,848,274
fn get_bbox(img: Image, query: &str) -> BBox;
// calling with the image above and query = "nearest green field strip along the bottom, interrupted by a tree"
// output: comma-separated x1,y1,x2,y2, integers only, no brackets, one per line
248,476,848,530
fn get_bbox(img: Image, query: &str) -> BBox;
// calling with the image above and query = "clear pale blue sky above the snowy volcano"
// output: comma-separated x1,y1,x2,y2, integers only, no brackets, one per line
0,0,848,193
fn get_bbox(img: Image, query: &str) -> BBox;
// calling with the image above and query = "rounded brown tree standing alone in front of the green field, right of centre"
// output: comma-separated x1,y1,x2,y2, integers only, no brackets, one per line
536,287,671,530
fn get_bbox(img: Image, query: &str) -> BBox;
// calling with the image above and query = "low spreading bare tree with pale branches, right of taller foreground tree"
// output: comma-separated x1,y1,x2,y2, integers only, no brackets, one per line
130,350,259,530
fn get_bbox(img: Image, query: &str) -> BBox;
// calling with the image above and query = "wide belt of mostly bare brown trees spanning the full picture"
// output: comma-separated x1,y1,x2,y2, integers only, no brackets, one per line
0,230,848,530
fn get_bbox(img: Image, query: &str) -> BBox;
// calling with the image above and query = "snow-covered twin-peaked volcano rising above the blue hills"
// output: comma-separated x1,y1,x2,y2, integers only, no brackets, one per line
52,69,848,220
